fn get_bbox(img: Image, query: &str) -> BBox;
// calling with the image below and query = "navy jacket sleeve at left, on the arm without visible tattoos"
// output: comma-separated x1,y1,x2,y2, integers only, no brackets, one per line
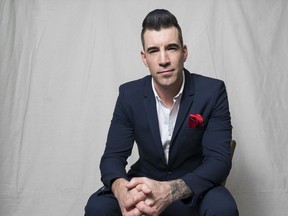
100,83,134,190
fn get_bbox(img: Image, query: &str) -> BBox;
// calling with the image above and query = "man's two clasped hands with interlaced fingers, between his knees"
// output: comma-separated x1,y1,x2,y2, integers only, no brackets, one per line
112,177,172,216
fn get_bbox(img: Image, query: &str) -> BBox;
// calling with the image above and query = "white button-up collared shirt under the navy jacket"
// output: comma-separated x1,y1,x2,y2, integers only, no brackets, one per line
152,72,185,164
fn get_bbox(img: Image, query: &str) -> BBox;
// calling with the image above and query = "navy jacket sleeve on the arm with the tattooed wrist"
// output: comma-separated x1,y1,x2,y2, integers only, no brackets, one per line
182,81,232,203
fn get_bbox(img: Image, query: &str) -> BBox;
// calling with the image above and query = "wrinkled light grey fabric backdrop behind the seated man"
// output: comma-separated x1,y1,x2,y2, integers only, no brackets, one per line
0,0,288,216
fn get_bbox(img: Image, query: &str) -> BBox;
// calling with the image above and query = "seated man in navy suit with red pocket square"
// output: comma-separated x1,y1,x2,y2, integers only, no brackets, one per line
85,9,238,216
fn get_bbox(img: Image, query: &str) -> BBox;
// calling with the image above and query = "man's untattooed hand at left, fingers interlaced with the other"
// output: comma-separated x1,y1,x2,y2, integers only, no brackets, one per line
112,178,156,216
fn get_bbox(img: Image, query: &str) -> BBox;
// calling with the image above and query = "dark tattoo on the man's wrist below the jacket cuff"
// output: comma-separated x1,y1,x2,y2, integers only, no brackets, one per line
168,179,193,202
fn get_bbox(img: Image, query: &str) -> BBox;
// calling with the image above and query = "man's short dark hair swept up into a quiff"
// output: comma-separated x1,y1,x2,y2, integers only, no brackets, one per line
141,9,183,48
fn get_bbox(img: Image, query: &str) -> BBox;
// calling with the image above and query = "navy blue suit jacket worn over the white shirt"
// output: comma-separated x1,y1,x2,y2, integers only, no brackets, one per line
100,69,232,204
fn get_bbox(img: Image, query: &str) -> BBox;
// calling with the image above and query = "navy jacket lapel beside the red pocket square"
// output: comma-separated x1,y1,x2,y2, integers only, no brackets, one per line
171,69,194,144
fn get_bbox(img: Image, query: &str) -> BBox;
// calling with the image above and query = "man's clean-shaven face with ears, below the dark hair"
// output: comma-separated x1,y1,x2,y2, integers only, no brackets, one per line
141,27,188,90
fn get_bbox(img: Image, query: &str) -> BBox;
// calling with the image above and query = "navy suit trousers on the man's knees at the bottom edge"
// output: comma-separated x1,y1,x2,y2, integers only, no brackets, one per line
85,186,239,216
